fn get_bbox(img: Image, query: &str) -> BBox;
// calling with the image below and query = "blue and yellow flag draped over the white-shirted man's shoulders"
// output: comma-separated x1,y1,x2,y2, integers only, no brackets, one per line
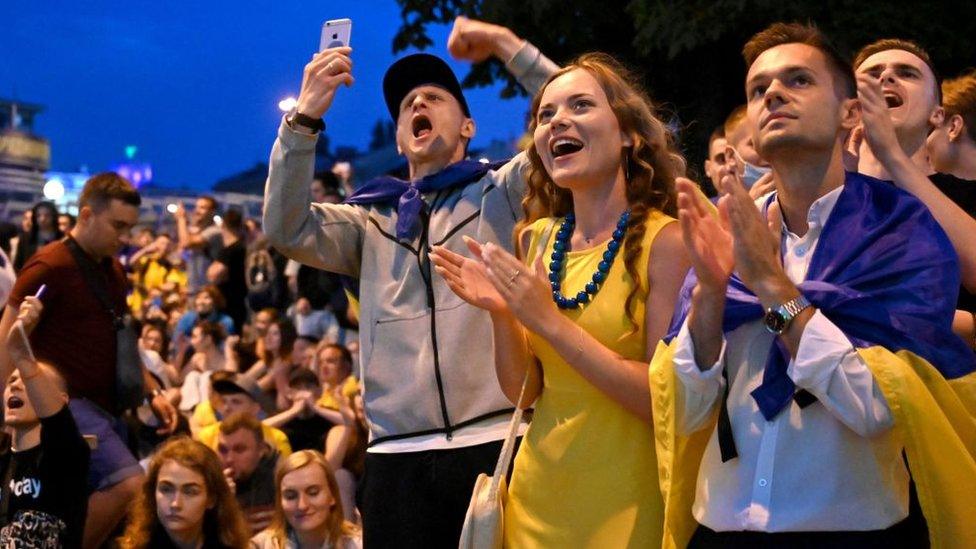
650,173,976,547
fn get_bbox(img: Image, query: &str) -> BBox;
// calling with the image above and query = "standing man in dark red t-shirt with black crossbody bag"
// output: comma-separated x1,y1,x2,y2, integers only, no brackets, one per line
0,172,177,546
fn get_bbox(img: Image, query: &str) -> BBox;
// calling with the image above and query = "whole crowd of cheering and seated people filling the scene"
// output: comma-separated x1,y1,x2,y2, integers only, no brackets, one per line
0,11,976,548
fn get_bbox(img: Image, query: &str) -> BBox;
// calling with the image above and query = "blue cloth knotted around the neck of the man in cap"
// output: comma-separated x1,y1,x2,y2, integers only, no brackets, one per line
345,156,508,240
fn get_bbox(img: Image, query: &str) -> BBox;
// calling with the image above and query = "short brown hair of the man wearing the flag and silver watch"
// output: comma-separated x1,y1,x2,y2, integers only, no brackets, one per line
742,23,857,99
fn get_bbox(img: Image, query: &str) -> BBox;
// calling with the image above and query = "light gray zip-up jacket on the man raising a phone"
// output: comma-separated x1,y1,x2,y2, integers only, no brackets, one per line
264,43,558,446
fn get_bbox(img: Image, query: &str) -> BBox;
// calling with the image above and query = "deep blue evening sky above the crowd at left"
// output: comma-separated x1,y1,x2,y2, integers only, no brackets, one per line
0,0,527,188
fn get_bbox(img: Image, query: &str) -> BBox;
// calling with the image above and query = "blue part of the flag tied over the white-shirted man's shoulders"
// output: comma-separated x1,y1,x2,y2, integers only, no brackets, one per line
665,173,976,420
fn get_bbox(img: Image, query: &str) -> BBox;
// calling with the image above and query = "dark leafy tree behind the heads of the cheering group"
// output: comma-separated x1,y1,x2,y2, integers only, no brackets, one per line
393,0,976,179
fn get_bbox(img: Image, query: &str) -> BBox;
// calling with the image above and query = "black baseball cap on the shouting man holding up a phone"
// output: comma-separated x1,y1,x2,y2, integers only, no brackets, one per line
383,53,471,122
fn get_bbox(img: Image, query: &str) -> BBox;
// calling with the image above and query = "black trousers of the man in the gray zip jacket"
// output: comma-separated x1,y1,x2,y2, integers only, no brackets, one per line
357,441,510,549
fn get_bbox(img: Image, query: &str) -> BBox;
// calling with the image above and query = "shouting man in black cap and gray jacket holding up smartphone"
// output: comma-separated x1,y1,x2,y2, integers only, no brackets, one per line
264,17,558,547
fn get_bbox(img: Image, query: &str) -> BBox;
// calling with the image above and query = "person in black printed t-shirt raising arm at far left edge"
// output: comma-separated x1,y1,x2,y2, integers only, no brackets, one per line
0,292,89,547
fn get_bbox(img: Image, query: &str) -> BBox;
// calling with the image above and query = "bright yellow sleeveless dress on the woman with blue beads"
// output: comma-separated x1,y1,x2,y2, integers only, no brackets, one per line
505,210,674,549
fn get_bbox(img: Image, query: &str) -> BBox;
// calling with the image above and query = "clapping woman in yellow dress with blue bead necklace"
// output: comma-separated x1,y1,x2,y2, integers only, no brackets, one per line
432,54,689,549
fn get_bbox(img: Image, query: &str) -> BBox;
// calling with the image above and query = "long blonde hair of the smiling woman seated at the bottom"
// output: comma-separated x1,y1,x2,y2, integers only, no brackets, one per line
268,450,356,547
